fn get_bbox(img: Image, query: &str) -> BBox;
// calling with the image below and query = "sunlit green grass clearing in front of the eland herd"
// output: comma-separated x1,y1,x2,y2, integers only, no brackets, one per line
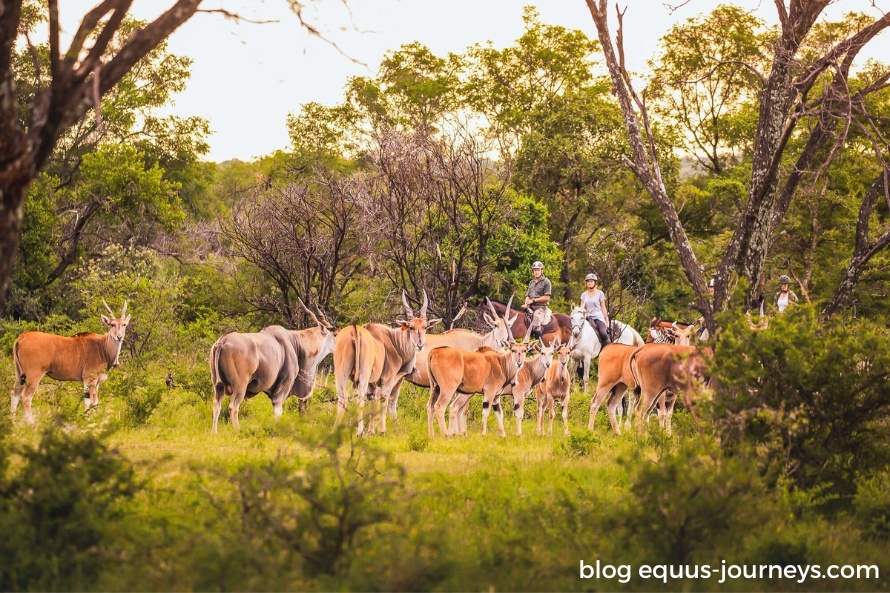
0,360,887,590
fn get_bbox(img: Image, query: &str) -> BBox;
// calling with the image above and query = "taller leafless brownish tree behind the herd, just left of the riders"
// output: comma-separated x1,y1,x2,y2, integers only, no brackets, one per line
360,128,513,325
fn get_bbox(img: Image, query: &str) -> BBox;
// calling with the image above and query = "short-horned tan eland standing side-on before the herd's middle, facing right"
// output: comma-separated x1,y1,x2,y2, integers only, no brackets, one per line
426,342,528,437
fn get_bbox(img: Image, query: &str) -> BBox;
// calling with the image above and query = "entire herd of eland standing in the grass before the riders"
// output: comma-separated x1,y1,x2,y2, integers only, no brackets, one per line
11,291,713,437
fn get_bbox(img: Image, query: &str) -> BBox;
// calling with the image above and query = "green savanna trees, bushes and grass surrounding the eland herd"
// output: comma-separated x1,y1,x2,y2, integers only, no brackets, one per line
0,0,890,591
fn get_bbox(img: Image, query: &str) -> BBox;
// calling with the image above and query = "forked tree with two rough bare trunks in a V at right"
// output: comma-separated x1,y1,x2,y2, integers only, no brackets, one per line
587,0,890,331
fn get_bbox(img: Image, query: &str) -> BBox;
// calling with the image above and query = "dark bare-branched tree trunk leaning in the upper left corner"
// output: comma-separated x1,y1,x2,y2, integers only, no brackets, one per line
0,0,332,309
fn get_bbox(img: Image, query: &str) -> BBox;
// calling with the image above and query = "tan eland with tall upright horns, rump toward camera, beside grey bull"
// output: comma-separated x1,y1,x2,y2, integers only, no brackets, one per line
334,290,441,434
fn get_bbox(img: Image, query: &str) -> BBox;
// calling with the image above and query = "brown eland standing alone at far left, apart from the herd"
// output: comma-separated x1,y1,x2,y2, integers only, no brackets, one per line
11,300,130,424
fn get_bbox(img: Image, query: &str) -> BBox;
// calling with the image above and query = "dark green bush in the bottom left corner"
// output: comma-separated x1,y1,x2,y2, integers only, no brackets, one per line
0,425,139,591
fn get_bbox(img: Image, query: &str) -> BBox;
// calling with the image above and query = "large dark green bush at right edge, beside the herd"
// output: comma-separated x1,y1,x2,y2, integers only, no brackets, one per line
713,305,890,494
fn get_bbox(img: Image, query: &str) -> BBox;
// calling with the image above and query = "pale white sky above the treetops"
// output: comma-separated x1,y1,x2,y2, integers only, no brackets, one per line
60,0,890,162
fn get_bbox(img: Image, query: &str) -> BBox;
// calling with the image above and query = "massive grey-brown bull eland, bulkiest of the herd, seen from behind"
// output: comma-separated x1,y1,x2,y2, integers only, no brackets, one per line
210,300,335,432
